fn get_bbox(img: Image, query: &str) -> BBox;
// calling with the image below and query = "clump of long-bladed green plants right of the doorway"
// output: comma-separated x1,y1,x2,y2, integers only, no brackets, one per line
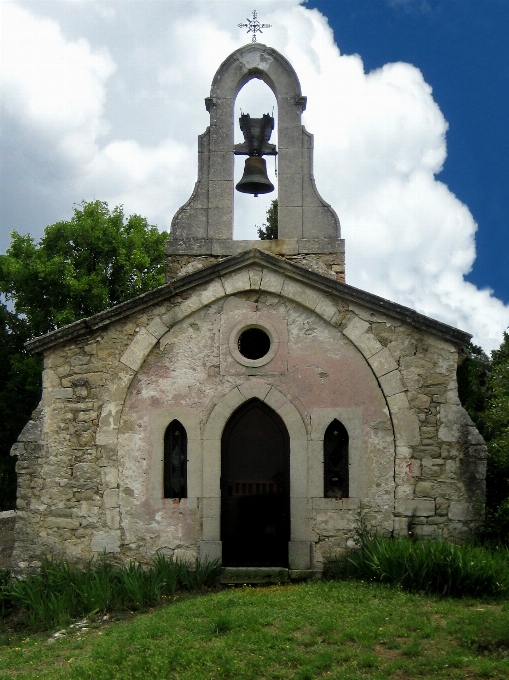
324,536,509,597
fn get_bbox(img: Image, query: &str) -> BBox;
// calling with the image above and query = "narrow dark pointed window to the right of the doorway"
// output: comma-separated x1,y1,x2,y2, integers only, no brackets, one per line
323,420,349,498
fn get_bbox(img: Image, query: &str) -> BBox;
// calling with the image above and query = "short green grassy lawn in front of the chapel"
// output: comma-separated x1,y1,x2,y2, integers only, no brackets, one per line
0,581,509,680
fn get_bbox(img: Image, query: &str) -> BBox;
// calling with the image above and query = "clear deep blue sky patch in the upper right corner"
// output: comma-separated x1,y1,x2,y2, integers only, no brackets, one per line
307,0,509,303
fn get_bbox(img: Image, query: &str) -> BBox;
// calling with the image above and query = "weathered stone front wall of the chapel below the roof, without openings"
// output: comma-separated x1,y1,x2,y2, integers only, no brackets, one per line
12,262,486,569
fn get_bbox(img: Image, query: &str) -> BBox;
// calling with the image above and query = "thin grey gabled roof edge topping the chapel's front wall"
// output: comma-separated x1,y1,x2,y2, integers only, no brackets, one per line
26,248,472,353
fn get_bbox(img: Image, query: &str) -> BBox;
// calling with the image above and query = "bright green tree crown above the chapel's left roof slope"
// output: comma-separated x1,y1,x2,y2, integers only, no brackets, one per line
0,201,168,336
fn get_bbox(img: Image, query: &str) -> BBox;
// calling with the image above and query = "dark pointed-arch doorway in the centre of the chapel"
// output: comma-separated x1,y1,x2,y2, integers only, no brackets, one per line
221,399,290,567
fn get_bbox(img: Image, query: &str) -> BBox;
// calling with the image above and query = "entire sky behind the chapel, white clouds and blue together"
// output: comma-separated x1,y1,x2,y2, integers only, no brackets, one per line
0,0,509,350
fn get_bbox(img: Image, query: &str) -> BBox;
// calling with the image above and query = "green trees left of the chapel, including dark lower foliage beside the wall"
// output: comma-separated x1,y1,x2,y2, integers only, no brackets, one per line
0,201,168,510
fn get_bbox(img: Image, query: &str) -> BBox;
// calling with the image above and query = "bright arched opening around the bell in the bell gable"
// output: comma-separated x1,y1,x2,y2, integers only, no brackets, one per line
233,78,278,240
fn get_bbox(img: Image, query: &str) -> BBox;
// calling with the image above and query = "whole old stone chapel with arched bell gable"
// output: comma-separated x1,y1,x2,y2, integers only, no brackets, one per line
12,43,486,578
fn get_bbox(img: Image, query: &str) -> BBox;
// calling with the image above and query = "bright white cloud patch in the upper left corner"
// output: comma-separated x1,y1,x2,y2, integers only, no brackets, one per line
1,2,115,158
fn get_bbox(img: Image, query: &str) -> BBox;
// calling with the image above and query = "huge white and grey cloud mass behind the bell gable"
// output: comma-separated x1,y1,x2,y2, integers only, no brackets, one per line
1,0,509,349
